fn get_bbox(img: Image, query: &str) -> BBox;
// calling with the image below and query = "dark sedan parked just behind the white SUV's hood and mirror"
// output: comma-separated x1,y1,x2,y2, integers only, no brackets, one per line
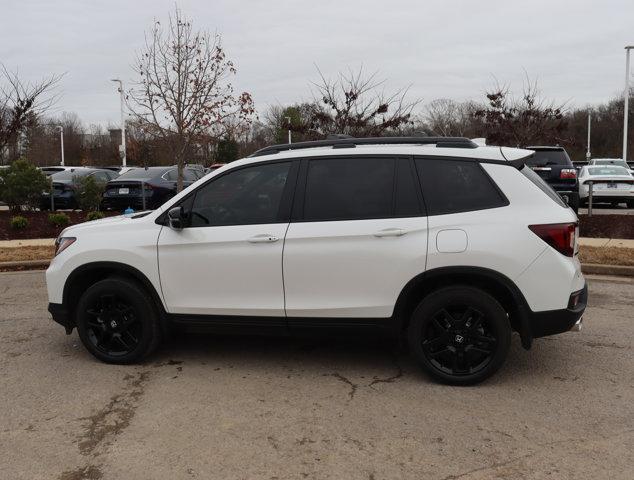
101,167,199,211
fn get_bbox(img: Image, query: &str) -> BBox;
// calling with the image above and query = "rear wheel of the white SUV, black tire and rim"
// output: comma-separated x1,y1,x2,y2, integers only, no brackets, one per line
407,285,511,385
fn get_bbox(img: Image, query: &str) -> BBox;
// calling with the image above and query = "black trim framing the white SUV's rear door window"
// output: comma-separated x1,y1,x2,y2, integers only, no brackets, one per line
291,153,427,223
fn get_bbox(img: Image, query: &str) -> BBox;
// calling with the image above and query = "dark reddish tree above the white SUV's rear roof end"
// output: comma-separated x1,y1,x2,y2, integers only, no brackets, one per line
473,81,567,147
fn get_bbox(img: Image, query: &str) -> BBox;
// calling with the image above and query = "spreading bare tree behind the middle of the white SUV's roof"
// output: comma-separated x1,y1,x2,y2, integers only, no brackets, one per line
308,67,420,136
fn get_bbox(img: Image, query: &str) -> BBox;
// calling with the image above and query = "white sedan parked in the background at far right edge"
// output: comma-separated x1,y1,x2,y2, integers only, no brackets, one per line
579,164,634,208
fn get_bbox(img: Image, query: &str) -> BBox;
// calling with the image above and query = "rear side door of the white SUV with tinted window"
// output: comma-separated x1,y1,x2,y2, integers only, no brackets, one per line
283,155,427,318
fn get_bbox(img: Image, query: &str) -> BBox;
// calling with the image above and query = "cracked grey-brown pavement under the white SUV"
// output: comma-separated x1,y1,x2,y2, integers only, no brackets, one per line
0,272,634,480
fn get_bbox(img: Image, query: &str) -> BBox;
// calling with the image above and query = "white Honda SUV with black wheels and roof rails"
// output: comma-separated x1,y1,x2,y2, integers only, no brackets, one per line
46,137,587,384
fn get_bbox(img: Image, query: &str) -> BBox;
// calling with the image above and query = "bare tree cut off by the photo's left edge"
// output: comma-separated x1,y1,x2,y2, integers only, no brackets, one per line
0,64,62,163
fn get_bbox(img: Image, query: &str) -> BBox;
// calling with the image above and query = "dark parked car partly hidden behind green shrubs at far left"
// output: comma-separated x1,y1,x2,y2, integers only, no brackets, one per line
40,167,117,210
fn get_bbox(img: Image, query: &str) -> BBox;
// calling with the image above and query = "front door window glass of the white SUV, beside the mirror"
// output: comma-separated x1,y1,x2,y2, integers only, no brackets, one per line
185,162,291,227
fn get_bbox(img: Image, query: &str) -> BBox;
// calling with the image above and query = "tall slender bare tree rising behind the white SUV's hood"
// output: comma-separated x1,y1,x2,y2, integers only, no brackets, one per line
130,9,255,191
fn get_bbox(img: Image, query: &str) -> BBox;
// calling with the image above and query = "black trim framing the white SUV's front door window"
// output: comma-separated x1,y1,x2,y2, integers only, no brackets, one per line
154,158,300,228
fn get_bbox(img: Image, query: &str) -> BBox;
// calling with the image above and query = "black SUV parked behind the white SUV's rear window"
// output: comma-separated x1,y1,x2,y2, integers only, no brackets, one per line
526,146,579,213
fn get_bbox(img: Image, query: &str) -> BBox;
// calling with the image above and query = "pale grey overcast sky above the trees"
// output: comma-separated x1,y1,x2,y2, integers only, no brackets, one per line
0,0,634,125
